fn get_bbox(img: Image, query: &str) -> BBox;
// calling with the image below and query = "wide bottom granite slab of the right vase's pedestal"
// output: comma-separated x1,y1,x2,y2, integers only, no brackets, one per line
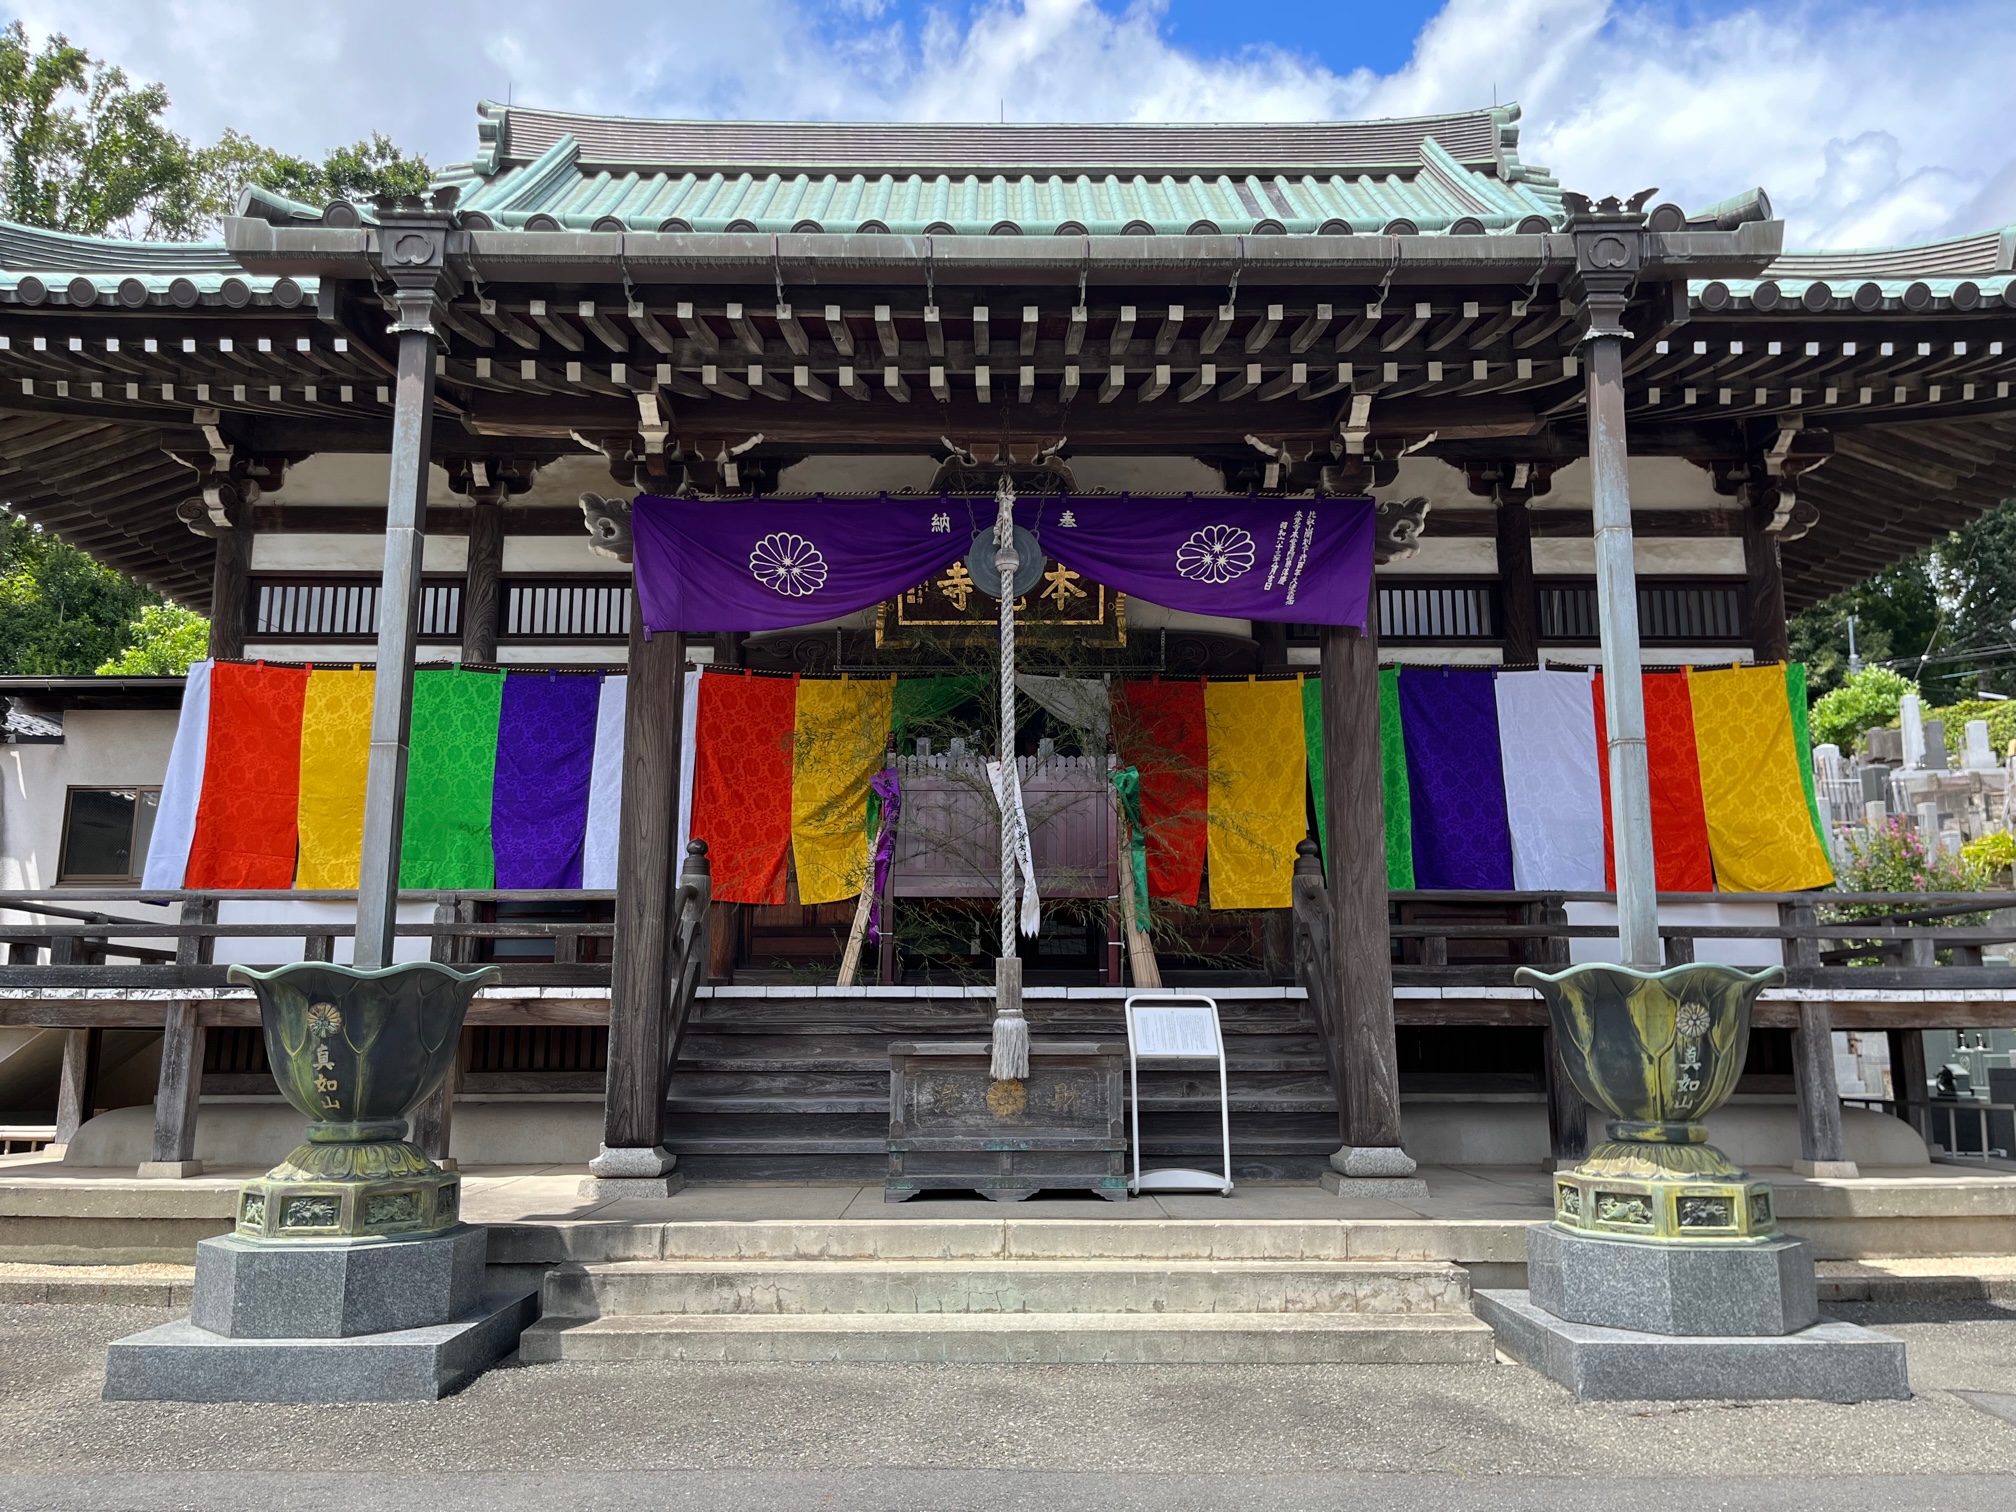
1476,1290,1911,1401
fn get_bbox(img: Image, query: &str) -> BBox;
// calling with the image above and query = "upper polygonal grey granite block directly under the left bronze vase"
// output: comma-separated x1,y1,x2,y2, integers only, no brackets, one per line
190,1224,490,1339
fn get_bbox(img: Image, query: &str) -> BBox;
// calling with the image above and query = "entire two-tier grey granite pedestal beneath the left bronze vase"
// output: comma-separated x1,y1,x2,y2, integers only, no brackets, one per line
105,1224,538,1401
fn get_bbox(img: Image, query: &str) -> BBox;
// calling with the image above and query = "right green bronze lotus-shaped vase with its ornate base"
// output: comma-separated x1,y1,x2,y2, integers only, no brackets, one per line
1514,962,1784,1244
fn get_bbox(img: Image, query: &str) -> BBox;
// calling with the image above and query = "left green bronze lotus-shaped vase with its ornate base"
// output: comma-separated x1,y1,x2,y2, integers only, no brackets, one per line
230,962,498,1240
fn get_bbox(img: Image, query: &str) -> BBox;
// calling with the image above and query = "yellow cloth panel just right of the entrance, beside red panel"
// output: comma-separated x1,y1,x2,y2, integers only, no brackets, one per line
1204,681,1308,909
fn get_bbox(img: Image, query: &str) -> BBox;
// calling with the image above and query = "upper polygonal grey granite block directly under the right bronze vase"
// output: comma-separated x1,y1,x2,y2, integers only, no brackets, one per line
1526,1224,1820,1337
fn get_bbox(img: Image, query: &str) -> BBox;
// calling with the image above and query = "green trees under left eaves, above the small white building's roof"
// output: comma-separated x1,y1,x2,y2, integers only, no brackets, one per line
0,518,161,677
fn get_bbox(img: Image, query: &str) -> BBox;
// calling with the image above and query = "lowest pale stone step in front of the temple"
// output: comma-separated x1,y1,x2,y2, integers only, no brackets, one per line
518,1312,1494,1365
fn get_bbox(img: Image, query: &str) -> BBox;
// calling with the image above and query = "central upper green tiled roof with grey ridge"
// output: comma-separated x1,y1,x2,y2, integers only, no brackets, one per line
421,105,1562,236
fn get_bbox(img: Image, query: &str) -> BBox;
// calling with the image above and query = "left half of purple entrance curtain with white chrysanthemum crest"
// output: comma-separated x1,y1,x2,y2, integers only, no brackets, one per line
631,494,971,631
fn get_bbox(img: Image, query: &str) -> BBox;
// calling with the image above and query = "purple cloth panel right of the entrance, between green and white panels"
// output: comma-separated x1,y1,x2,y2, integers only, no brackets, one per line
1399,667,1512,889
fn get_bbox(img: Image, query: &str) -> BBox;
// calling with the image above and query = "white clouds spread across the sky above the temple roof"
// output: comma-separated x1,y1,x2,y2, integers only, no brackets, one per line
22,0,2016,246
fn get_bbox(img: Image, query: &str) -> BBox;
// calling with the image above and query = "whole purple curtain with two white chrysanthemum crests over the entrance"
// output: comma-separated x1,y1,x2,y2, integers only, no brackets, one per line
631,494,1375,631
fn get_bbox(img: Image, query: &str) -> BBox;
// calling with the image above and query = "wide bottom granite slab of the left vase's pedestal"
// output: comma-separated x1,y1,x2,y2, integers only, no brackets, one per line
105,1292,538,1401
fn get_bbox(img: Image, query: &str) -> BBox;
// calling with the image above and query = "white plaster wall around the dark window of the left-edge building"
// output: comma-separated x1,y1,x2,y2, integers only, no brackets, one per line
0,710,177,907
